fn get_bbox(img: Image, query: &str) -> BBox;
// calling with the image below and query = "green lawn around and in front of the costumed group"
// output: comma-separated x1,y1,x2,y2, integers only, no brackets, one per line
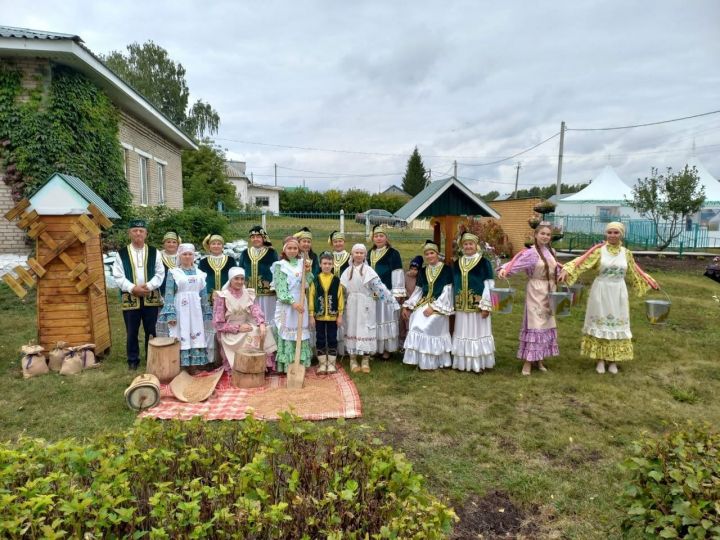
0,236,720,539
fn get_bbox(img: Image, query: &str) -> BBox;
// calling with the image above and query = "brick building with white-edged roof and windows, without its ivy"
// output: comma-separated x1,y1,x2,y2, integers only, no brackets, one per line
0,26,197,253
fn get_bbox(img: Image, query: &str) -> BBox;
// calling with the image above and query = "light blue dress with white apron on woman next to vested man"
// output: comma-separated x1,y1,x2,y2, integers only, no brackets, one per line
158,267,215,367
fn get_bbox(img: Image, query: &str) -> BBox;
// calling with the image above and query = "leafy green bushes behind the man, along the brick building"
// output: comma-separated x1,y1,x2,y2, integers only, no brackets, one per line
105,206,229,249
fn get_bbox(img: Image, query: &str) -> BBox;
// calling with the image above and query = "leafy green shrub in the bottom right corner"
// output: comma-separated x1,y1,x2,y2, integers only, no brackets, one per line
620,424,720,538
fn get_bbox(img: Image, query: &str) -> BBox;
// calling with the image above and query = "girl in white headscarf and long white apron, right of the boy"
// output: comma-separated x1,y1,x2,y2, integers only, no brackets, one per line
340,244,400,373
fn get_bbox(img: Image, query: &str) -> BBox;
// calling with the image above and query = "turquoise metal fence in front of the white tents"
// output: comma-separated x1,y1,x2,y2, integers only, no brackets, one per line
547,214,713,252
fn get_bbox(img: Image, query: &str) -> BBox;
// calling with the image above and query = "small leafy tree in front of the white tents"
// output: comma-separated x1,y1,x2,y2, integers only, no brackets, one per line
628,165,705,251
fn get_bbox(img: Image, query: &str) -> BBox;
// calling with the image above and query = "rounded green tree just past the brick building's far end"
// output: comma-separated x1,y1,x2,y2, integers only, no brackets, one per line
182,139,238,210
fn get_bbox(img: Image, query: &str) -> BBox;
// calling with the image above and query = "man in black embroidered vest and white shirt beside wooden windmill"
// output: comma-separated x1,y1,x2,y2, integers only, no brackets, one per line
113,219,165,370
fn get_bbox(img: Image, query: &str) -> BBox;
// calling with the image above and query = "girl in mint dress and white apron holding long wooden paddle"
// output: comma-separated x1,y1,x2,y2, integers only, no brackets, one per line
271,236,314,373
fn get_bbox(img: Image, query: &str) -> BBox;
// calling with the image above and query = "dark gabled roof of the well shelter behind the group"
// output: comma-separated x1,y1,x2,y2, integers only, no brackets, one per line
395,176,500,222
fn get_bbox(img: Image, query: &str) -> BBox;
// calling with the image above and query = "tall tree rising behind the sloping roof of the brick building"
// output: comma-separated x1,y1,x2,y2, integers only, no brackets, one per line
103,41,220,139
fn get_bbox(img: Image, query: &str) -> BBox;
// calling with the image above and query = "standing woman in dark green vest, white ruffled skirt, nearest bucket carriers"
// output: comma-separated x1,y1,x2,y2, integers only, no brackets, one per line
452,232,495,373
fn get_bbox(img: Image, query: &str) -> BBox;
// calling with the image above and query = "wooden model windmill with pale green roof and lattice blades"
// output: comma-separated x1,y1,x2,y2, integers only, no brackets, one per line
3,173,120,355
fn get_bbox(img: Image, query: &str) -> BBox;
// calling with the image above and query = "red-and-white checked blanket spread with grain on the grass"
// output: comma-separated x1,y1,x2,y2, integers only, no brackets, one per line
140,367,362,420
